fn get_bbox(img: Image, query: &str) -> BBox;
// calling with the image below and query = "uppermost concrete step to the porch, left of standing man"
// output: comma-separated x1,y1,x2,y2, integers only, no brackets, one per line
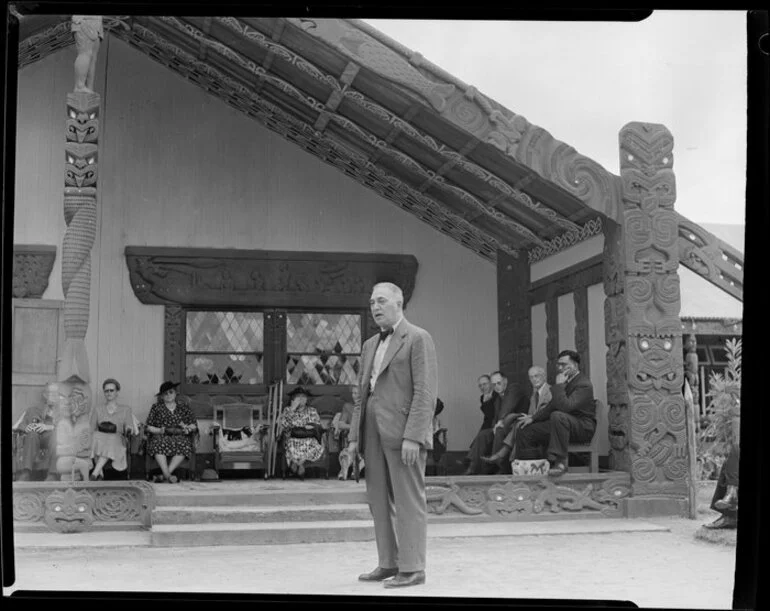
155,484,366,507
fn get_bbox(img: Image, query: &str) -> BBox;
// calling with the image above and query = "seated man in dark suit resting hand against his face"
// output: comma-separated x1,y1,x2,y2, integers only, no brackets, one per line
515,350,596,476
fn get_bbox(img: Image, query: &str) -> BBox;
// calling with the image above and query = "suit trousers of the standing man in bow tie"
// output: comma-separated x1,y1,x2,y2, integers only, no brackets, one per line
364,406,428,573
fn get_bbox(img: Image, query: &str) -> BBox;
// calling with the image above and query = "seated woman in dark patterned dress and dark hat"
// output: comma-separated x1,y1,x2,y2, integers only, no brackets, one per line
146,381,198,484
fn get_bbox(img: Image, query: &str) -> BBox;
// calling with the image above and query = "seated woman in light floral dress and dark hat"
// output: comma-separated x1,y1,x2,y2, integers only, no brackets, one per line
278,386,325,477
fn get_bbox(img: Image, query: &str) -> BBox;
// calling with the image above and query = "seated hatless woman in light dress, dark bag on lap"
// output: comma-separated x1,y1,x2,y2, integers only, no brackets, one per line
91,378,135,480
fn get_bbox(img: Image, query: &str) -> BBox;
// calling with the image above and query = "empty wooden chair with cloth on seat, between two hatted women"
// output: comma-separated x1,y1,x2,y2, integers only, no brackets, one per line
209,403,269,473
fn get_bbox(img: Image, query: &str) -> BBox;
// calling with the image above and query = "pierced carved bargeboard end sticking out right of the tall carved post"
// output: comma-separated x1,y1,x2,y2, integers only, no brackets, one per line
677,213,743,301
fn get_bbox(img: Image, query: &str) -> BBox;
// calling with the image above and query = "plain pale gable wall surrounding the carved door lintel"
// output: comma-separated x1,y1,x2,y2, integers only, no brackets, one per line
14,39,498,450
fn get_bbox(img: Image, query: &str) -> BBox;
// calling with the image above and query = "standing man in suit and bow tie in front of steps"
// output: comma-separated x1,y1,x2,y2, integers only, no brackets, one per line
348,282,438,588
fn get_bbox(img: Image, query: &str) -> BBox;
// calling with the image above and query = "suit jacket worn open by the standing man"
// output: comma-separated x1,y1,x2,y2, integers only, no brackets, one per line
349,318,438,454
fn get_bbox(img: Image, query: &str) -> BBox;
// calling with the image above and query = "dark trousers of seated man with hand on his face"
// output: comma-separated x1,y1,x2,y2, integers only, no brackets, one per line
515,411,596,462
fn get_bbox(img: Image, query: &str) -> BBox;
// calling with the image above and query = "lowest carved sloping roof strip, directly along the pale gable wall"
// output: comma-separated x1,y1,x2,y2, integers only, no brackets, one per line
116,24,510,261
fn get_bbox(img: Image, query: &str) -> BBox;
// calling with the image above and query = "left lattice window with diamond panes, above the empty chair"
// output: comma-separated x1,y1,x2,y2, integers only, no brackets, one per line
185,311,265,384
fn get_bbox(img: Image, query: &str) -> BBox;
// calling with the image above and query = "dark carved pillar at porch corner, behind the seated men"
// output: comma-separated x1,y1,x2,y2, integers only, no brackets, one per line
497,250,532,389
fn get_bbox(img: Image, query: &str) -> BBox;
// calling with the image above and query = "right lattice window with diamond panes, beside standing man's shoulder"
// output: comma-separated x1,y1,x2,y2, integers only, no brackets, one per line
286,312,362,386
